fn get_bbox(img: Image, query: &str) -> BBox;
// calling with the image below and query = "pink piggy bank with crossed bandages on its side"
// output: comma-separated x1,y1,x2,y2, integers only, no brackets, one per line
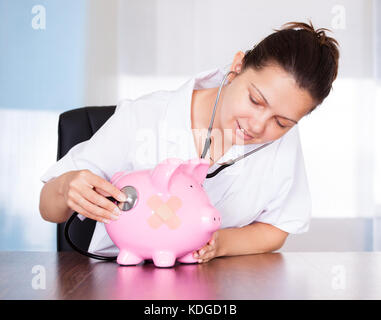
105,158,221,267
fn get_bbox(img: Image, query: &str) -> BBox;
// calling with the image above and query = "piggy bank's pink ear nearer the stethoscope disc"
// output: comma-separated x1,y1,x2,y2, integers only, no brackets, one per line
151,158,184,193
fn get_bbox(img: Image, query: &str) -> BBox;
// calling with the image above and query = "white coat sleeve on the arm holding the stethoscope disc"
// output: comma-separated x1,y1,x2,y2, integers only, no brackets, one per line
40,99,136,220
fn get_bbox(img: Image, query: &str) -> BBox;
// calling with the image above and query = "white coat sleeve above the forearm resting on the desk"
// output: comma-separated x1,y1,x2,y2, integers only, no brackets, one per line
255,126,312,234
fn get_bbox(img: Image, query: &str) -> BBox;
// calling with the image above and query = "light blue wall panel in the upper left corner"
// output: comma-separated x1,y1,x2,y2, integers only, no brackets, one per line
0,0,86,109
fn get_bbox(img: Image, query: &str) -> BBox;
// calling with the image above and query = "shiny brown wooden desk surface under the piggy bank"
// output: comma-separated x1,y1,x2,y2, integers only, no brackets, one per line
0,251,381,300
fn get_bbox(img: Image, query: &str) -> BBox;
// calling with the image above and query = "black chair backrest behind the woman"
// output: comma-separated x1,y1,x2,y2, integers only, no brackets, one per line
57,106,116,251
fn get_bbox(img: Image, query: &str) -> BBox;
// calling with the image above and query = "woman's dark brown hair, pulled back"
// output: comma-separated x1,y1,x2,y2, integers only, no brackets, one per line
242,21,339,113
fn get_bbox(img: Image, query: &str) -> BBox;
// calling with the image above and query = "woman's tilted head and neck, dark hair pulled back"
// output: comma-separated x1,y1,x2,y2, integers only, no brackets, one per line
193,22,339,159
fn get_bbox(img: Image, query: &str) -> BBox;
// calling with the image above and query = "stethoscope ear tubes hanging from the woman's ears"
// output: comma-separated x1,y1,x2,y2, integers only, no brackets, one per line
201,71,274,179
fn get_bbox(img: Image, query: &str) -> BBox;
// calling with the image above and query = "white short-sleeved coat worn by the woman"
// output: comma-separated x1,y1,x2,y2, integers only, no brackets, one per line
40,66,311,253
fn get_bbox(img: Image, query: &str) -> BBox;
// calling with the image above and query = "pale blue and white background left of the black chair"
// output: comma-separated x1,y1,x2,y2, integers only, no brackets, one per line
0,0,88,251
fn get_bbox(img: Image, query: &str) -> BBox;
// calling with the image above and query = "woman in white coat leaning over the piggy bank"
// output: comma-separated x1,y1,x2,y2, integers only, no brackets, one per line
40,22,339,263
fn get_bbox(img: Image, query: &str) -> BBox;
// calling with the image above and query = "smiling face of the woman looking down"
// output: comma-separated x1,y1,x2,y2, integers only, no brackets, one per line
219,64,314,144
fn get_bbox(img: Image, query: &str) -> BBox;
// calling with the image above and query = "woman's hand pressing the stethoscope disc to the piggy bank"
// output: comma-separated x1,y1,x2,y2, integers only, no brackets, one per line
61,169,126,223
